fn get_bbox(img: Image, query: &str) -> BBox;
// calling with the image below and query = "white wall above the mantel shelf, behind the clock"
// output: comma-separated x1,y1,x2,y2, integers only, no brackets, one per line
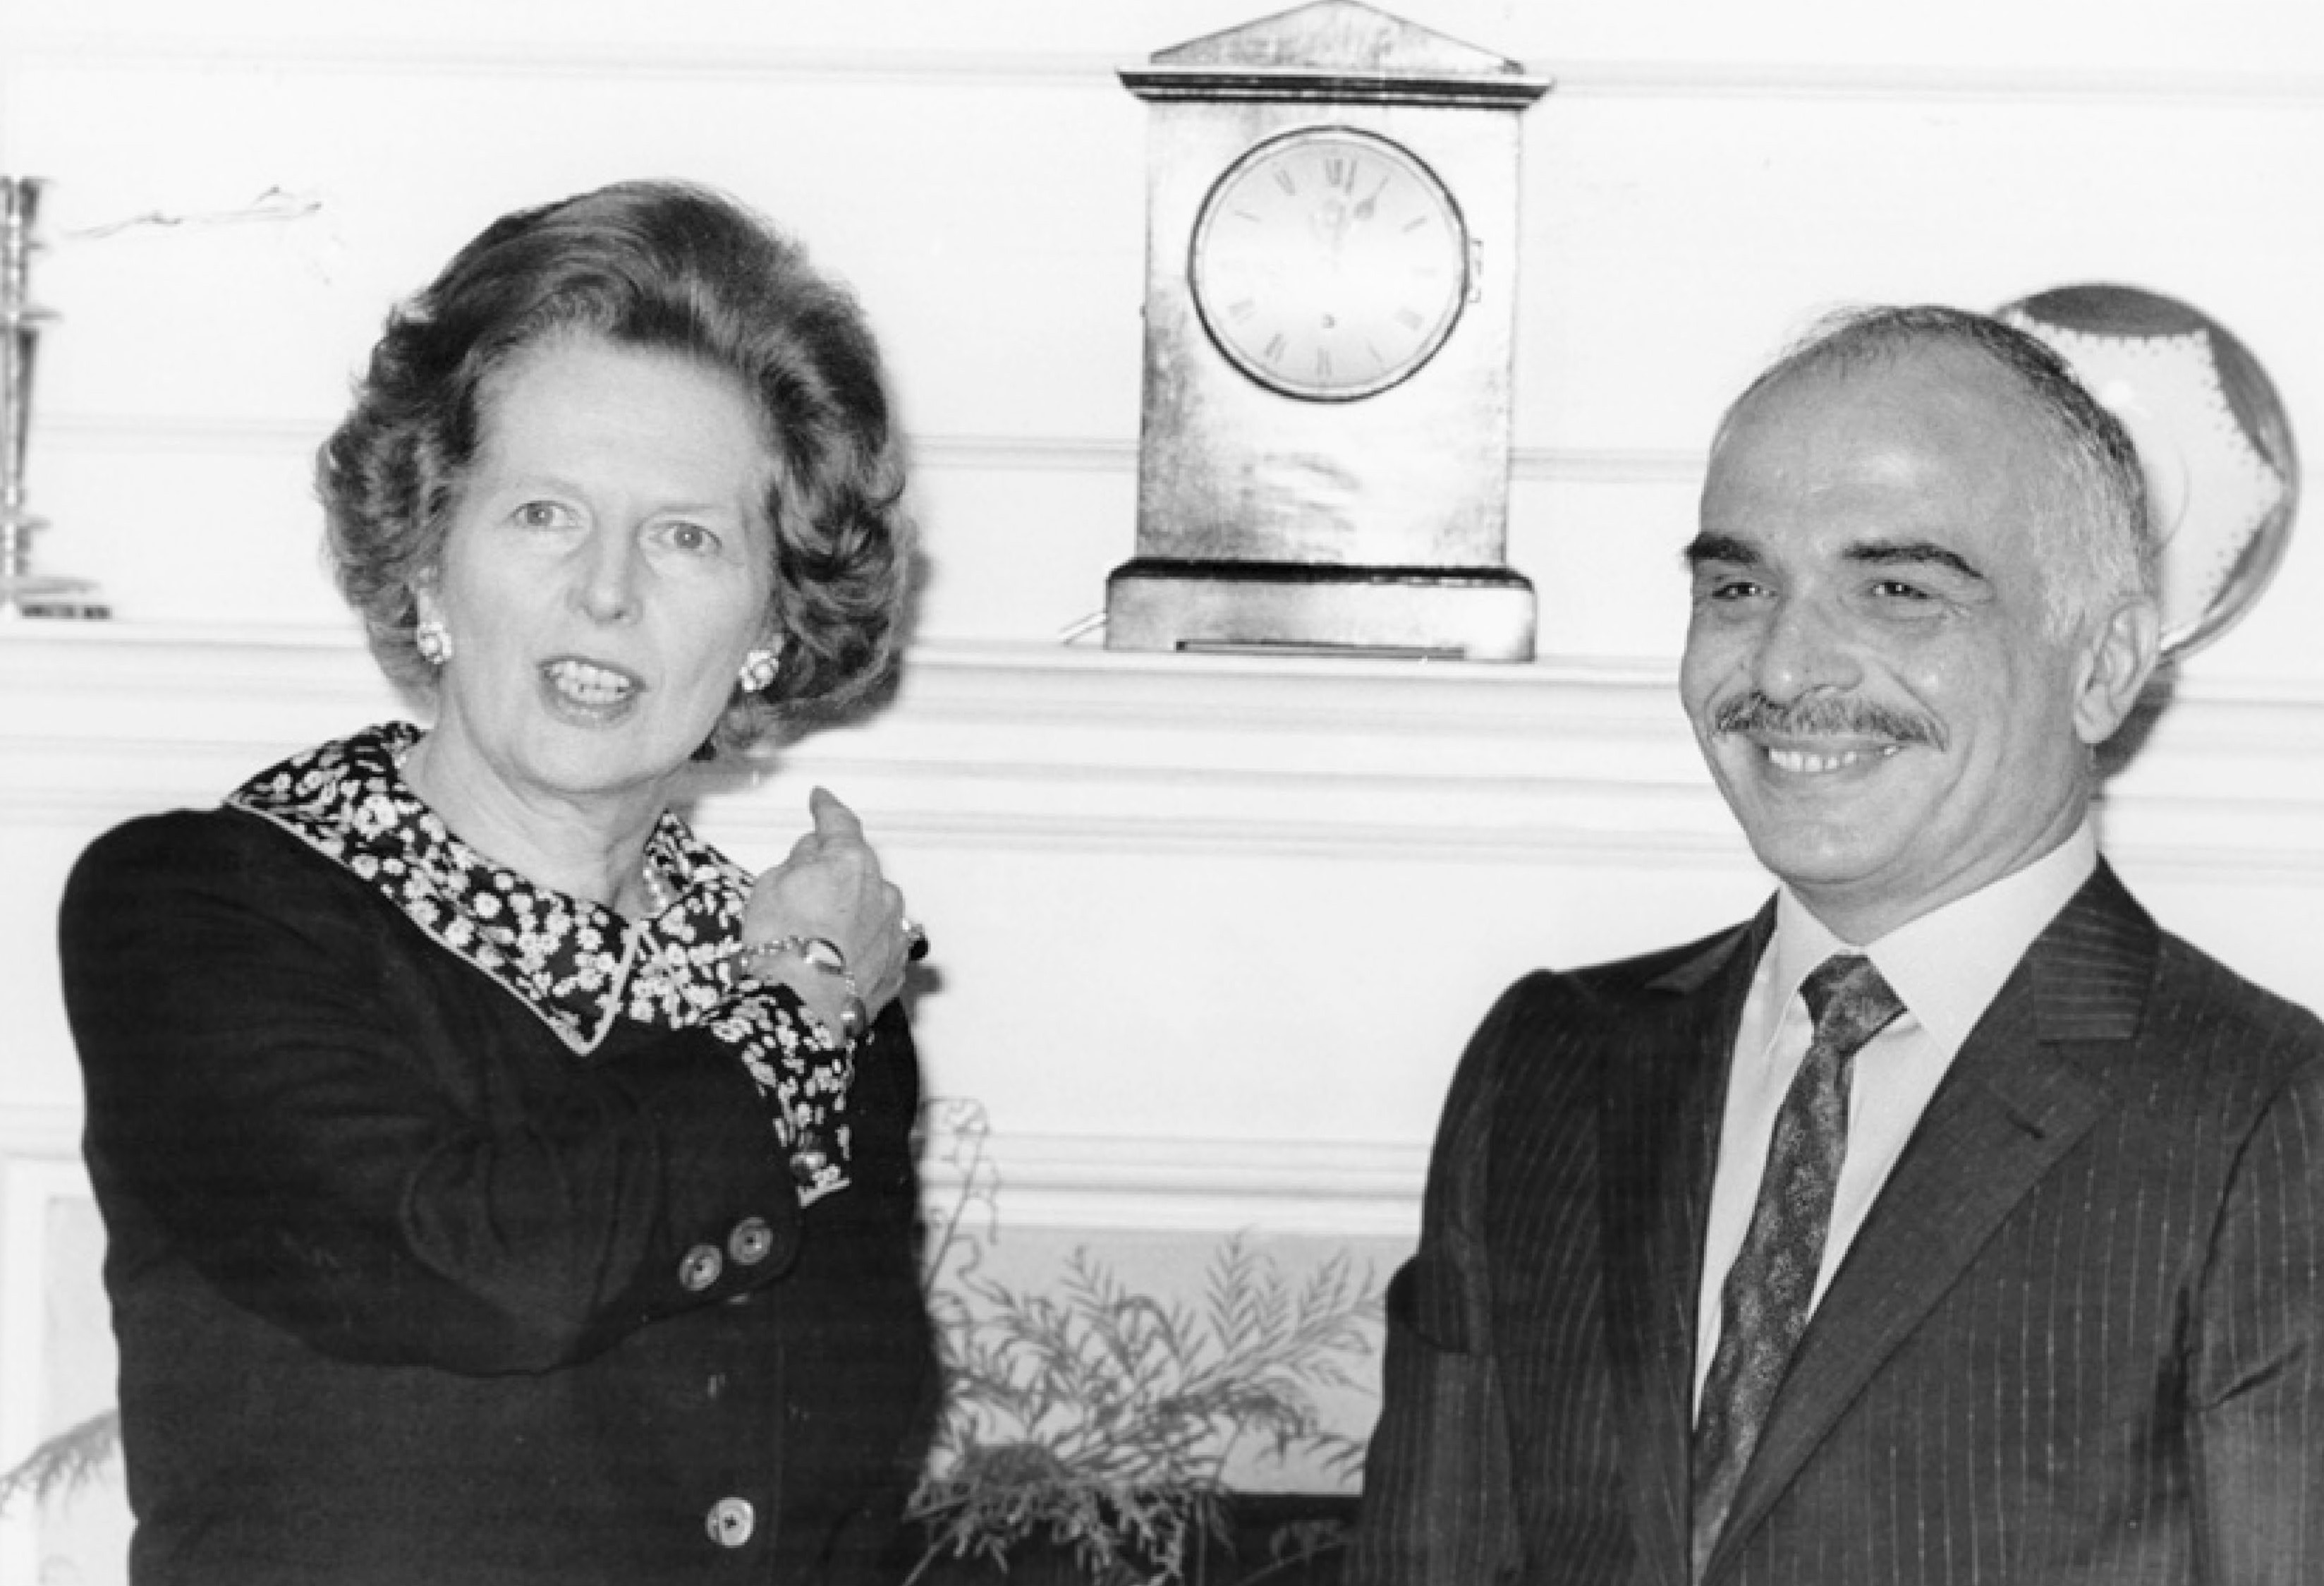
13,0,2324,679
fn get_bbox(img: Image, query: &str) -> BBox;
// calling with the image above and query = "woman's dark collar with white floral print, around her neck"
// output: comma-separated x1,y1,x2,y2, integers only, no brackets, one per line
226,721,750,1055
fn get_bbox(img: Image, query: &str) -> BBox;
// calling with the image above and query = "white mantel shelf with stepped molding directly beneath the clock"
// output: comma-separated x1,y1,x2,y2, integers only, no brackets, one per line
0,621,2324,881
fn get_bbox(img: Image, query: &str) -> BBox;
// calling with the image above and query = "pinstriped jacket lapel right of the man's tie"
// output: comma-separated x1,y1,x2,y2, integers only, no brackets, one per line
1712,865,2157,1572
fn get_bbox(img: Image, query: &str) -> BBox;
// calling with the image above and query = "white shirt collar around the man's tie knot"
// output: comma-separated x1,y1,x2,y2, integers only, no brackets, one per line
1773,818,2098,1058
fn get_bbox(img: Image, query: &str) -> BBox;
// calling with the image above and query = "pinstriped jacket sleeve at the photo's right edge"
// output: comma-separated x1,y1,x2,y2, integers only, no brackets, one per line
2187,1037,2324,1586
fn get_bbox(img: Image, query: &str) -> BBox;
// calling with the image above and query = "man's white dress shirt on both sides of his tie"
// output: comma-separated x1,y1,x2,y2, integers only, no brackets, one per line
1694,821,2098,1409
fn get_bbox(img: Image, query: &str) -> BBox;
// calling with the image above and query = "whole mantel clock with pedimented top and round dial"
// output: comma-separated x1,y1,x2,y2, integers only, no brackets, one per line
1106,0,1547,660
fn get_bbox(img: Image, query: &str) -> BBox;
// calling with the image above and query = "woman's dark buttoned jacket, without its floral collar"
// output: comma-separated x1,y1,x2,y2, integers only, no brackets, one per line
63,809,932,1586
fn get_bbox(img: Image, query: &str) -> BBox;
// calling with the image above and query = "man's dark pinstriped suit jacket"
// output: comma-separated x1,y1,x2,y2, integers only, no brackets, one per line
1348,867,2324,1586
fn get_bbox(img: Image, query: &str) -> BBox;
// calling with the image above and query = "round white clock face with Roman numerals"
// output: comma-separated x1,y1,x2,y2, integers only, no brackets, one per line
1188,128,1468,402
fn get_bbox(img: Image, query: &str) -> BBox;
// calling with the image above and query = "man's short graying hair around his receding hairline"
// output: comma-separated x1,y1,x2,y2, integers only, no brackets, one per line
1710,305,2159,633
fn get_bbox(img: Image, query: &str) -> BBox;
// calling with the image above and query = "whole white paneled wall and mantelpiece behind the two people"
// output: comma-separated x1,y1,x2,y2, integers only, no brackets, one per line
0,0,2324,1579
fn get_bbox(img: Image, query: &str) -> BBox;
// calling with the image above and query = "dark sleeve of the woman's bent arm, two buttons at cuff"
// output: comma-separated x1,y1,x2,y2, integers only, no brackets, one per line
63,814,855,1374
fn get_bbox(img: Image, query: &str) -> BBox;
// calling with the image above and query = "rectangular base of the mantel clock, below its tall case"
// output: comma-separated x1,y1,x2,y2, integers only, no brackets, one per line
1106,556,1534,660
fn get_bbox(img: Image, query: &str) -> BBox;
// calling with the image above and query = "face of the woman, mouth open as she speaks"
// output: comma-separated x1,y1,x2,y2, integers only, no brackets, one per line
420,332,774,823
